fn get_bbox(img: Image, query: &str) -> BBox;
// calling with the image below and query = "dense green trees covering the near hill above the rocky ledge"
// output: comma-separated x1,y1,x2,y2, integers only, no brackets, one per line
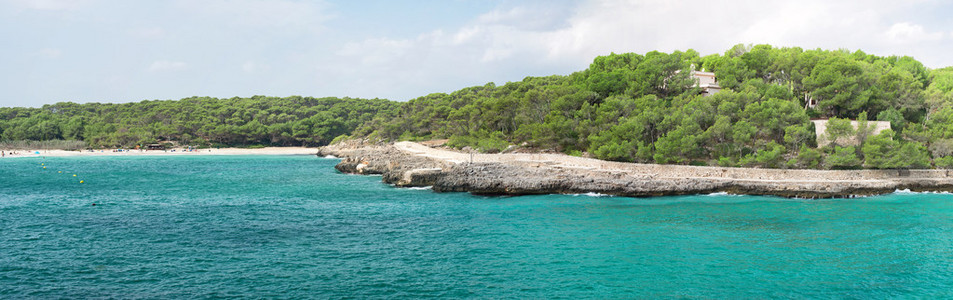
362,45,953,168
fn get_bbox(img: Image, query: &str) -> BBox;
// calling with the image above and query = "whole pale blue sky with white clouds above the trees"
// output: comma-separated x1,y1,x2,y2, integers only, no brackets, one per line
0,0,953,107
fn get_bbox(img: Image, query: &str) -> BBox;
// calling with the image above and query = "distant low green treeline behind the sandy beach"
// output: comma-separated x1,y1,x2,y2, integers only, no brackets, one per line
0,96,400,147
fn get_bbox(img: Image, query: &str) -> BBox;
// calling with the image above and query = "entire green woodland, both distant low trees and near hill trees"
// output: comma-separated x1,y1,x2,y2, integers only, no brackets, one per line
0,45,953,168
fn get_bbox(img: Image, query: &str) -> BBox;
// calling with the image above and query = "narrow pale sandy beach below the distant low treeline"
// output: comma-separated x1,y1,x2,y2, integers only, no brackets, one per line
3,147,318,158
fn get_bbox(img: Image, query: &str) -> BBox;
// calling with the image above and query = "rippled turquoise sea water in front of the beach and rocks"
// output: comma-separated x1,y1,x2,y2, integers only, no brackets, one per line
0,156,953,299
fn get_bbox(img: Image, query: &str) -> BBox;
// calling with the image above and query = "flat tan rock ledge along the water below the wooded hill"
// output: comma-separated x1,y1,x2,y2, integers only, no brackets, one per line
318,141,953,198
